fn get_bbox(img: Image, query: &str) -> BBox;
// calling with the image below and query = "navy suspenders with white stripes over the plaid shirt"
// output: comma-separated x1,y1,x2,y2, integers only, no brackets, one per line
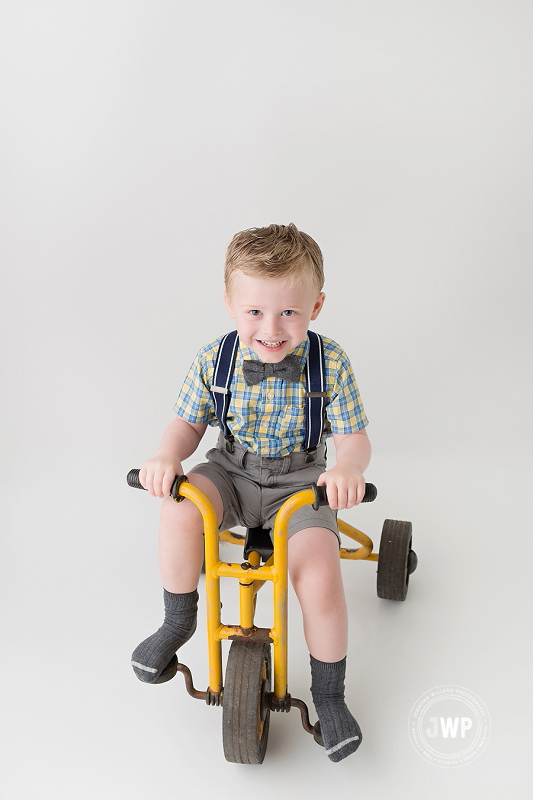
211,331,326,452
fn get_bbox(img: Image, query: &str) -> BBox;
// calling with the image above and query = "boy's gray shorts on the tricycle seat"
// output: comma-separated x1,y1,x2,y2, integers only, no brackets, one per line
189,436,340,544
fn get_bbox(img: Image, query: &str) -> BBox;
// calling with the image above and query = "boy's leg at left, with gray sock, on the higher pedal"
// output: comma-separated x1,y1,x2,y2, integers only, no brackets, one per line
131,474,223,683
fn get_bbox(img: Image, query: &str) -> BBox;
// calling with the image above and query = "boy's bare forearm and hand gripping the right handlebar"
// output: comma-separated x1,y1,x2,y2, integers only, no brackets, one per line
317,428,371,509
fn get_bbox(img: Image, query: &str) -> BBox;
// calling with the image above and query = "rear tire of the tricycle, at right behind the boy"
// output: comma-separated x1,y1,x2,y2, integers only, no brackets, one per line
378,519,413,600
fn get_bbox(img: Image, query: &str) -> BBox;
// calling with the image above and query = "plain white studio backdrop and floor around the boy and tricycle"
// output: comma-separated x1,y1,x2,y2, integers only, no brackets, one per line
0,0,533,800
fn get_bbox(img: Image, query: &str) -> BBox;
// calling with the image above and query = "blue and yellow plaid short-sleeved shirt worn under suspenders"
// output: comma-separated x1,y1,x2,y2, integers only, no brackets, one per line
174,336,368,458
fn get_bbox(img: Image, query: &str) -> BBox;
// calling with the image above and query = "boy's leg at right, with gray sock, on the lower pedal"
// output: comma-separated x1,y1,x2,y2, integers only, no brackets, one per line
289,528,362,761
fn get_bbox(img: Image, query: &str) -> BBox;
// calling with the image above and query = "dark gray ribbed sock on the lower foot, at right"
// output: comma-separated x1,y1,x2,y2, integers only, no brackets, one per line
311,656,363,761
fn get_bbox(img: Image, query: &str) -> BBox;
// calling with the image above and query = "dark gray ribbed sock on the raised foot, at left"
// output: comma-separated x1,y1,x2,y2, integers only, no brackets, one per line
131,589,198,683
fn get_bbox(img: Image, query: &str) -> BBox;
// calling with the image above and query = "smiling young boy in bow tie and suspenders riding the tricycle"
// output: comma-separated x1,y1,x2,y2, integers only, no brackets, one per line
132,224,370,761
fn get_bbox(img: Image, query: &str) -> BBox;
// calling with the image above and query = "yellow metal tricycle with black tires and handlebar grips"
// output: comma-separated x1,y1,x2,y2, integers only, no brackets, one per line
127,469,417,764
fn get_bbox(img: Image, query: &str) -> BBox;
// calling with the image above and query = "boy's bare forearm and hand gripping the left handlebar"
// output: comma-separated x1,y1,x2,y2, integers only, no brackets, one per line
139,416,207,497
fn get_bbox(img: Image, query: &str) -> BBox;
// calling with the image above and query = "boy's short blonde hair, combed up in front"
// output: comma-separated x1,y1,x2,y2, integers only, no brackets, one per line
224,222,324,292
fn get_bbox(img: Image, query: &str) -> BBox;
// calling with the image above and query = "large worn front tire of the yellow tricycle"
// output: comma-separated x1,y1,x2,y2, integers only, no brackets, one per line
222,640,272,764
